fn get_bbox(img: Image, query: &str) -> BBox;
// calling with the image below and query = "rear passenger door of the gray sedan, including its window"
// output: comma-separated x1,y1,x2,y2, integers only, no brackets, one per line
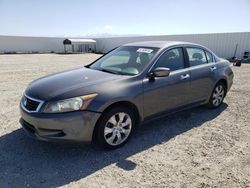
185,47,217,102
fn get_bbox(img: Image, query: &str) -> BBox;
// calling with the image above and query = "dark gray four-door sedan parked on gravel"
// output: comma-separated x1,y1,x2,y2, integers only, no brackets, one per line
20,41,234,149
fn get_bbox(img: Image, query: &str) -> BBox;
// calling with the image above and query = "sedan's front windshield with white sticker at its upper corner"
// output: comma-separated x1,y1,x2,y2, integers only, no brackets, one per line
89,46,159,75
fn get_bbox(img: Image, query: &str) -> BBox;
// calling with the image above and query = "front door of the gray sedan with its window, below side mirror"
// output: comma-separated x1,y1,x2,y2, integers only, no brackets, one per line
143,47,190,117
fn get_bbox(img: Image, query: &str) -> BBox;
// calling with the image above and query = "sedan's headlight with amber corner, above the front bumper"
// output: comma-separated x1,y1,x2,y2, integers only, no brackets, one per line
43,93,97,113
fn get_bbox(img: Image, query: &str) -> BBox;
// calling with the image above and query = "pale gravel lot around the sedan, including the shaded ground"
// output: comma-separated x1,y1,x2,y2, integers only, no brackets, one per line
0,54,250,188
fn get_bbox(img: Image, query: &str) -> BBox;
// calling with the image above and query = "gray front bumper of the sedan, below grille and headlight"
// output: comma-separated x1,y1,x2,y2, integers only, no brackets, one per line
20,107,101,142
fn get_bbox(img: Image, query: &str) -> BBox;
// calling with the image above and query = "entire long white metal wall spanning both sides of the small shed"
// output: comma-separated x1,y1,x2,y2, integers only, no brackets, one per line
0,32,250,58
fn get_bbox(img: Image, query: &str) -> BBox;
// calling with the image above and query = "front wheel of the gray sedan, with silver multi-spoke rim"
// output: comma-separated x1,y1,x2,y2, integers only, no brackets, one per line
95,107,136,149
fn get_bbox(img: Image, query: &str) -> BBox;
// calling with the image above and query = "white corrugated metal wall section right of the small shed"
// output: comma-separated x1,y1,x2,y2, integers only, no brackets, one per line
95,32,250,58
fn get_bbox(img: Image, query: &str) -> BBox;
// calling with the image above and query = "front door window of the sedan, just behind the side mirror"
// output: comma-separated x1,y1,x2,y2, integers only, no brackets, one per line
156,48,184,71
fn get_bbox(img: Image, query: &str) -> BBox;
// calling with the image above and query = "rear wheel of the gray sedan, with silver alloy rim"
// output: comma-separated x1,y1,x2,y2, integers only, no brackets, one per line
208,82,226,108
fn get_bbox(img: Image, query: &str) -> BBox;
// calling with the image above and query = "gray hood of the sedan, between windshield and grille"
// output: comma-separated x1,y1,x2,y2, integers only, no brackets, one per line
25,68,122,101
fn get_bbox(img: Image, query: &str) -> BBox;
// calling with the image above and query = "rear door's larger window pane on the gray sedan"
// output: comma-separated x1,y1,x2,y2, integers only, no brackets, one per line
186,48,207,67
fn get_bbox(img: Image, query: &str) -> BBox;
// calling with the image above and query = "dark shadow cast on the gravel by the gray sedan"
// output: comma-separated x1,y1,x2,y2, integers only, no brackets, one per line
0,103,227,187
